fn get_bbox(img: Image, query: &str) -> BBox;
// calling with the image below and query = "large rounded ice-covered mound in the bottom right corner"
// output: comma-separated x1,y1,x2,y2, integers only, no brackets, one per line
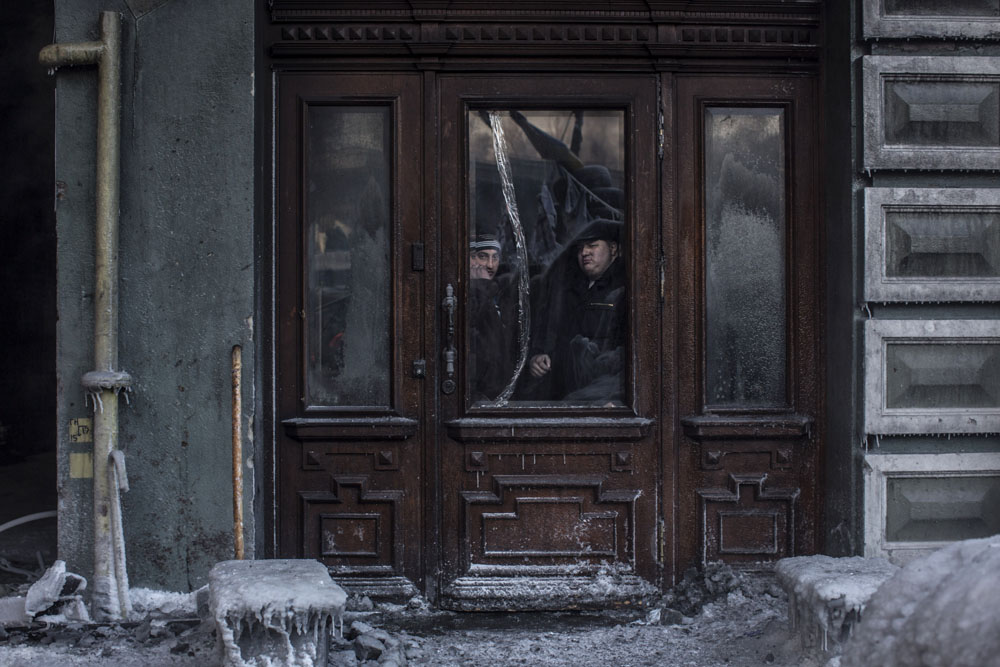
840,536,1000,667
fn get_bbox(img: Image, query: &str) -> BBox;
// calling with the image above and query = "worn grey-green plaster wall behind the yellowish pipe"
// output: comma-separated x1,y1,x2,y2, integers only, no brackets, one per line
55,0,255,590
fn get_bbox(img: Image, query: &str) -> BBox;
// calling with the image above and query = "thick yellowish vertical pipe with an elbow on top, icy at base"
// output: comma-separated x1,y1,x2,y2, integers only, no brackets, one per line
39,12,131,620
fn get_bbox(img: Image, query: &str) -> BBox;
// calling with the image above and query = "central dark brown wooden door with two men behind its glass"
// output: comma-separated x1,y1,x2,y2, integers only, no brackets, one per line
435,76,661,609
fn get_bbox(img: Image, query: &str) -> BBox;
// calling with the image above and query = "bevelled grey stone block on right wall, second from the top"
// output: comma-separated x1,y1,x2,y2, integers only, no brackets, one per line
863,56,1000,169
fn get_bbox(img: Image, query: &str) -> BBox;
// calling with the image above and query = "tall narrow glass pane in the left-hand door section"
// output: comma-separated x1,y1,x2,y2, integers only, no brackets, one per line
304,106,391,406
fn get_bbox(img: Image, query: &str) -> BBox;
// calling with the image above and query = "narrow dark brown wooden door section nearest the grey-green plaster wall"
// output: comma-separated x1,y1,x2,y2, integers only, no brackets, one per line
275,73,433,597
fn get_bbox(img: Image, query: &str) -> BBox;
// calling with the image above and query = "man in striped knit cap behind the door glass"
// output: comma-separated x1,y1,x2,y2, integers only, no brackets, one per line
469,234,518,401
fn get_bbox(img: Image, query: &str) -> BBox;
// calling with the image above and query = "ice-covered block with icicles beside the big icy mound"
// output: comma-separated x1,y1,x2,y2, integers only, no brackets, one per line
775,556,899,650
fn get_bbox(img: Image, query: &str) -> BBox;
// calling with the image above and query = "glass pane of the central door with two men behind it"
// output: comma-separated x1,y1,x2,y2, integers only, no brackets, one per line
466,109,628,407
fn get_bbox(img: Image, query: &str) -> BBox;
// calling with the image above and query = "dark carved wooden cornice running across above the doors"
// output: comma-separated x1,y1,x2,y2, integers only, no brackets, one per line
269,0,820,58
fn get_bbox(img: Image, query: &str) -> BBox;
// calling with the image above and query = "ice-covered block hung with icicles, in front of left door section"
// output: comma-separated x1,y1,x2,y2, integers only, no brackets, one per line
208,560,347,667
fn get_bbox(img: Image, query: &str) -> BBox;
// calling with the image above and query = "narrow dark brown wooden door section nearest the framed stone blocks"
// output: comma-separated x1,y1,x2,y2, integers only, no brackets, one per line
663,75,824,571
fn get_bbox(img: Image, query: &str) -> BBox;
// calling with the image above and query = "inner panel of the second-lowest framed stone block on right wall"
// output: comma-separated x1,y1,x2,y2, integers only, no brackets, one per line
885,342,1000,409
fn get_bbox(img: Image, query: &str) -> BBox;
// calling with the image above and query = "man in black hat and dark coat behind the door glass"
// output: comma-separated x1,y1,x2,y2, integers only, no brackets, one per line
528,219,626,405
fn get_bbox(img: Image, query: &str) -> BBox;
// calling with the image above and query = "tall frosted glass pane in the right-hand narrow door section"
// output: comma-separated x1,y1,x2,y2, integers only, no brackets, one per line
705,107,787,408
